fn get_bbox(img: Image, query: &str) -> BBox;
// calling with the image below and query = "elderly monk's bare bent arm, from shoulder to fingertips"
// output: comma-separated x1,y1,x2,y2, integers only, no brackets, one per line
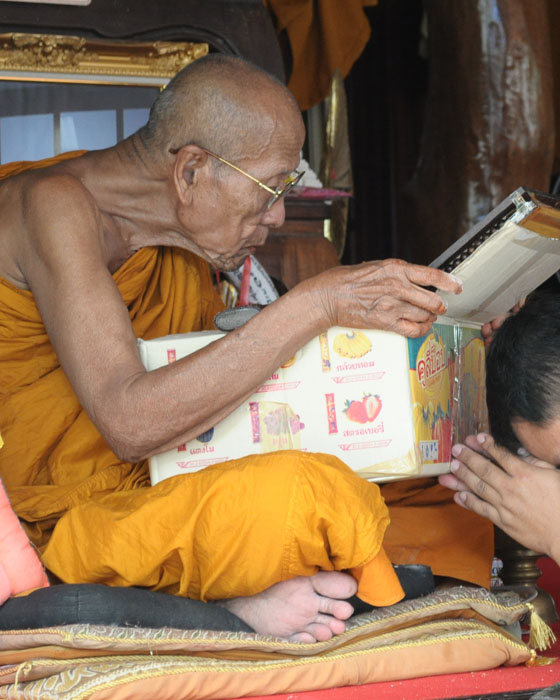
21,176,459,461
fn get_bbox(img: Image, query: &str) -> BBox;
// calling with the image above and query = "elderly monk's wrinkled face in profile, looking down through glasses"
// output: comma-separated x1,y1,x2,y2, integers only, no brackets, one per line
183,106,304,270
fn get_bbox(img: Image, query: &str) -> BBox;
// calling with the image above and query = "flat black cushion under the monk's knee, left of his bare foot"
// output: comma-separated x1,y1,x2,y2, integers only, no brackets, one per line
0,583,253,632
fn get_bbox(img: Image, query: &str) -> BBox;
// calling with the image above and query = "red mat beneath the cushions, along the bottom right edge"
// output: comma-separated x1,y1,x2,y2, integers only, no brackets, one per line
230,559,560,700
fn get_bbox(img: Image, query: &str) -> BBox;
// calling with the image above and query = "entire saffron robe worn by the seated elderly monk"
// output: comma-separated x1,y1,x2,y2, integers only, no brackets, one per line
0,154,492,605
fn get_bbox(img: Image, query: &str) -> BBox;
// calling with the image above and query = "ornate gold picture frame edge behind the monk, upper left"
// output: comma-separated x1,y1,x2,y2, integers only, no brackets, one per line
0,33,208,87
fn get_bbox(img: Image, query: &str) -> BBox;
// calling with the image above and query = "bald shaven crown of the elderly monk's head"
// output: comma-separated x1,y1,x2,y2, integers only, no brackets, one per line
140,54,303,161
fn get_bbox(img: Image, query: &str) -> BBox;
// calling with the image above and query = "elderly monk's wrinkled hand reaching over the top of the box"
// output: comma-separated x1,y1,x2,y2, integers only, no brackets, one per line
314,259,462,338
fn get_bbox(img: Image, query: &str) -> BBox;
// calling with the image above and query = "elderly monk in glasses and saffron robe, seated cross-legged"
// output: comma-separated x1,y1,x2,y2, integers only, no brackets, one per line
0,56,492,642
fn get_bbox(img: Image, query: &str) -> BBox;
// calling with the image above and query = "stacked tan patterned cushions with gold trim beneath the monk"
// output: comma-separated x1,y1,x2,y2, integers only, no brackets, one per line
0,587,536,700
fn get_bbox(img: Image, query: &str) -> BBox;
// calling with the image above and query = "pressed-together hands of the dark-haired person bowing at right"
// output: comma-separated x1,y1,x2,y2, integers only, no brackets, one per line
439,433,560,564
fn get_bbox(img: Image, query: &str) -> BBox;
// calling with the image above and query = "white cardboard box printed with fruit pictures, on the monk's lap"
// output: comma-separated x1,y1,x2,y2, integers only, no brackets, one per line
139,317,486,484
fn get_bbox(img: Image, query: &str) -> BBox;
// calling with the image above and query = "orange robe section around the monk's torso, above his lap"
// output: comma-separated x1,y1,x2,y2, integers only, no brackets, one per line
0,248,222,546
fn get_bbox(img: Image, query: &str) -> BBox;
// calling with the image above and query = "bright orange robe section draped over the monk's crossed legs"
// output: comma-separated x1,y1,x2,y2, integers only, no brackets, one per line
43,451,403,605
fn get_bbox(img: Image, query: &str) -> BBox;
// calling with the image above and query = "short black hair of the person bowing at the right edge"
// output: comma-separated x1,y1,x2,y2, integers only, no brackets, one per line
486,292,560,453
